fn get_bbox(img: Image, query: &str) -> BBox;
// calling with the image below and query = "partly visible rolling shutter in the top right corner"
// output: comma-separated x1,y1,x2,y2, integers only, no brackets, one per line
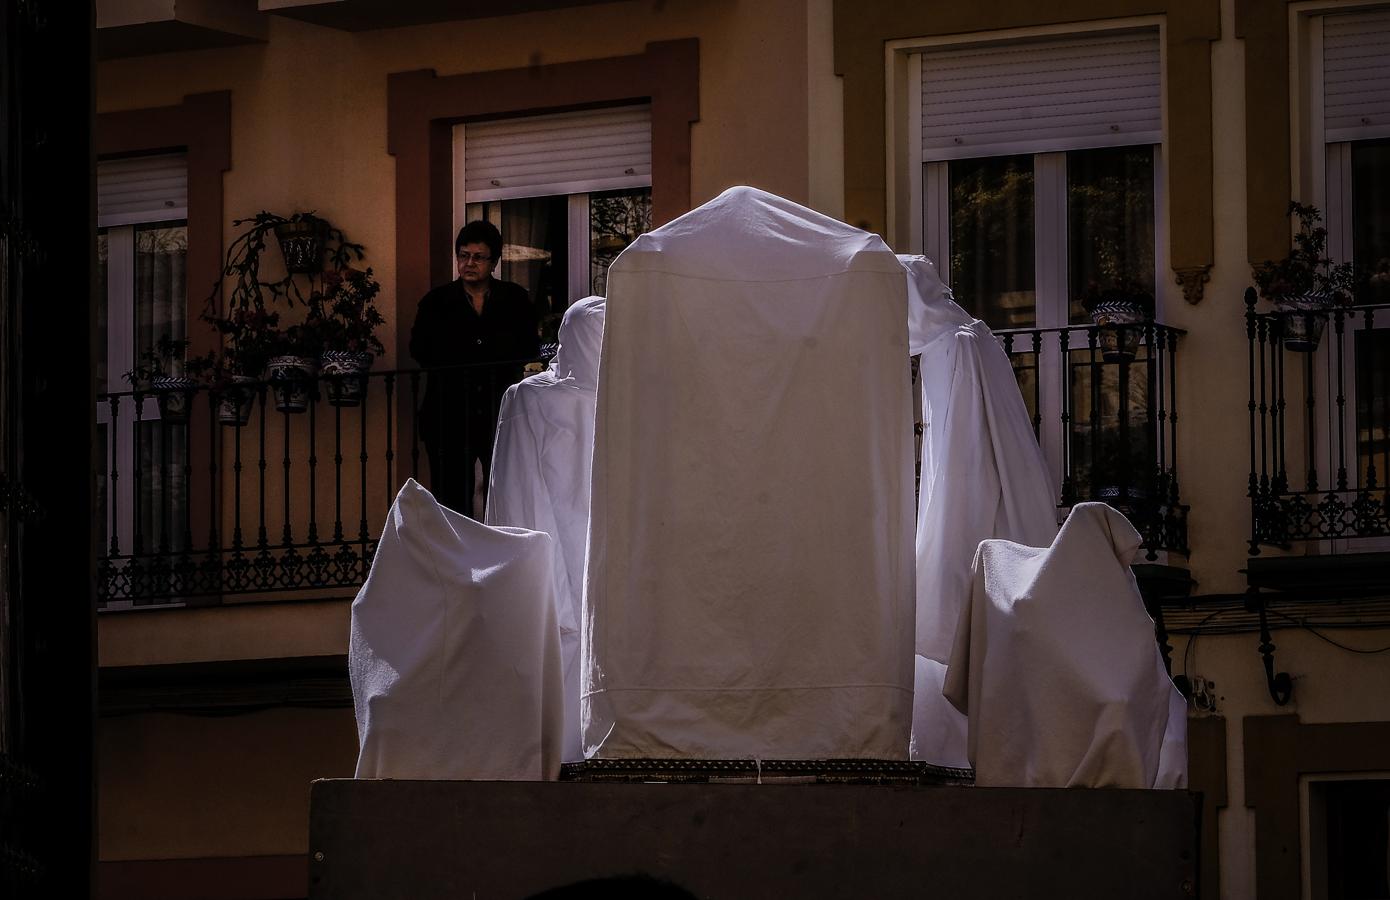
1322,11,1390,143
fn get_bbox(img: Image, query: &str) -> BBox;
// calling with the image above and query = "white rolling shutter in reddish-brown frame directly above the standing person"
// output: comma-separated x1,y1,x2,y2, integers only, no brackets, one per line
455,104,652,203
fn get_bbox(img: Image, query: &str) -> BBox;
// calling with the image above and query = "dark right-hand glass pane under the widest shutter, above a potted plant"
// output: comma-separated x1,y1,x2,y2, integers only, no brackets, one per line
1066,146,1155,323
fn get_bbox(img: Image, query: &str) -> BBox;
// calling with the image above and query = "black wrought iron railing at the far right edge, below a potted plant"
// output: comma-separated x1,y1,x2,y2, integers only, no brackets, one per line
1245,289,1390,555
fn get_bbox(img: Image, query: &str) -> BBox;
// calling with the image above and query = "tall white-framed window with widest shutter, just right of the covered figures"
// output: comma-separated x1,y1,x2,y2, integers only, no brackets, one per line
908,28,1162,505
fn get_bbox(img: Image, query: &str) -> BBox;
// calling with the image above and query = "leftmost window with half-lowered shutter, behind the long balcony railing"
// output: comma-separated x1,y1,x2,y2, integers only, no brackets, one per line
96,154,188,578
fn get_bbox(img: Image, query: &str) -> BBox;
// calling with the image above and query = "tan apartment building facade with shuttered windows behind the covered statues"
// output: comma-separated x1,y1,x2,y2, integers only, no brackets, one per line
95,0,1390,897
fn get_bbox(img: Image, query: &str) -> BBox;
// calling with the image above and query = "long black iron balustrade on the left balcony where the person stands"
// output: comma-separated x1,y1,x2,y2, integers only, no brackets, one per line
97,362,542,608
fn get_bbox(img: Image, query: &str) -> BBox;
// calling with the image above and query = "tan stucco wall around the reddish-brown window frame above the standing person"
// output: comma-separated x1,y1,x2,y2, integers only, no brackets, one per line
96,0,823,364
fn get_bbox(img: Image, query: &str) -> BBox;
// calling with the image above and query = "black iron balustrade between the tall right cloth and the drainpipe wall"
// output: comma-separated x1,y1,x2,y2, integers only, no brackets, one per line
995,323,1188,561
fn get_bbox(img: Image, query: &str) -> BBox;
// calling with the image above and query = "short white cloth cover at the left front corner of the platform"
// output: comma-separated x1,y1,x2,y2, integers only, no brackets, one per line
348,479,563,780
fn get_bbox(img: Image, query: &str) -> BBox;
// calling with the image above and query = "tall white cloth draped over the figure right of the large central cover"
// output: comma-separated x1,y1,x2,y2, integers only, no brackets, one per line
899,256,1056,664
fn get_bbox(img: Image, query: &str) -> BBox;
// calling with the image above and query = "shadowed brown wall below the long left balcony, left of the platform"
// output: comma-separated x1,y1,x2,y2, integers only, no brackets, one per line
97,708,357,860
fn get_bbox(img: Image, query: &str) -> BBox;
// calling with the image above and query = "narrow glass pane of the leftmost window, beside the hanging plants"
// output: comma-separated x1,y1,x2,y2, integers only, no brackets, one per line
135,225,188,374
